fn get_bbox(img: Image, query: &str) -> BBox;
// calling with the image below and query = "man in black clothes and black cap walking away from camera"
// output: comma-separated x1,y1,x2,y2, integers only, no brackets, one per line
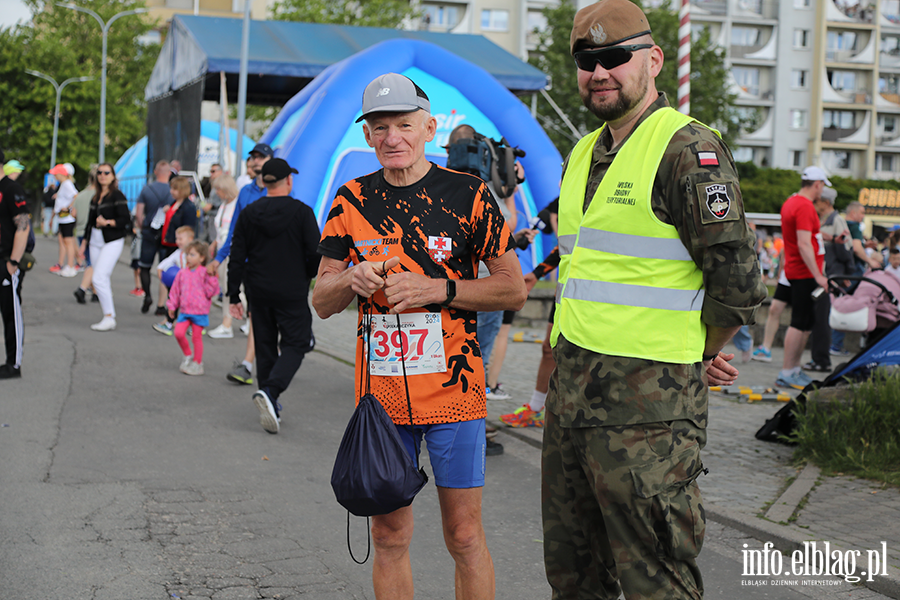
228,158,319,433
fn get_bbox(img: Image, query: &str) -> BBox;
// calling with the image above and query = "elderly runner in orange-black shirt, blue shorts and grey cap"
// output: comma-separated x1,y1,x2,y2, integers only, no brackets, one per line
313,73,526,600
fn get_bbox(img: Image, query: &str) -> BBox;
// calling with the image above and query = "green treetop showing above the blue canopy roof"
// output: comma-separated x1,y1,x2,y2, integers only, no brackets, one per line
272,0,419,29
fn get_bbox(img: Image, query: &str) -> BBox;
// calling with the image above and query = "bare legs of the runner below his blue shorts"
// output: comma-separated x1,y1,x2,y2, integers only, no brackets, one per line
372,487,494,600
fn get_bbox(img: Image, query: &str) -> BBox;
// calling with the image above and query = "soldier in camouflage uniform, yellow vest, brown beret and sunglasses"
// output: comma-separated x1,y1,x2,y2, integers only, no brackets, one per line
541,0,766,600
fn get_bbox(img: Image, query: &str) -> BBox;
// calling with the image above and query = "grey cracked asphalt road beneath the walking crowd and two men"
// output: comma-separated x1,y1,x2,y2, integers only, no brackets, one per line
0,240,880,600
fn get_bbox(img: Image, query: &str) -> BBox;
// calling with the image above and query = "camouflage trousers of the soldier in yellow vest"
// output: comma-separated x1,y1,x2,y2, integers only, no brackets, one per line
541,411,706,600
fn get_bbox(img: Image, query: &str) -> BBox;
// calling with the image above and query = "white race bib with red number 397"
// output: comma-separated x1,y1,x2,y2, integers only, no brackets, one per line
367,313,447,376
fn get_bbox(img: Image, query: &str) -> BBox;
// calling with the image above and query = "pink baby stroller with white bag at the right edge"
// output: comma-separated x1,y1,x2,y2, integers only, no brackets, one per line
828,271,900,347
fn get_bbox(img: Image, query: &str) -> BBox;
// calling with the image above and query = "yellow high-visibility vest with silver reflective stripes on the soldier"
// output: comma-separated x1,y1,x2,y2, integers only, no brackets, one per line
551,108,706,364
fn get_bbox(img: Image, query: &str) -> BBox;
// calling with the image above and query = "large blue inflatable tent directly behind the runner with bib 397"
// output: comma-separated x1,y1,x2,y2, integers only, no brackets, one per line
260,39,562,271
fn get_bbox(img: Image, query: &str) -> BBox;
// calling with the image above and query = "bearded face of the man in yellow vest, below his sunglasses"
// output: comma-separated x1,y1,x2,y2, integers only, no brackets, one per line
578,39,662,122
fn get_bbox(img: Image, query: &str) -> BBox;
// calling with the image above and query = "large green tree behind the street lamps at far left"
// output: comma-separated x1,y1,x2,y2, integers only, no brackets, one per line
0,0,159,197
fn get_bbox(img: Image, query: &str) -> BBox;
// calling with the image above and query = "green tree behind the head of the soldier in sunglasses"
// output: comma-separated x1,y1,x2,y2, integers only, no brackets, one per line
529,0,750,156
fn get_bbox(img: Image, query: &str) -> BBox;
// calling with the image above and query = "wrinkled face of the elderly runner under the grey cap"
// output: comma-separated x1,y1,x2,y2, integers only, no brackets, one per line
363,110,437,171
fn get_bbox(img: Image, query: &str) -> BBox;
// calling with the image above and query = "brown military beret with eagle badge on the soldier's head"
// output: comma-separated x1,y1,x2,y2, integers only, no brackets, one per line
569,0,650,54
